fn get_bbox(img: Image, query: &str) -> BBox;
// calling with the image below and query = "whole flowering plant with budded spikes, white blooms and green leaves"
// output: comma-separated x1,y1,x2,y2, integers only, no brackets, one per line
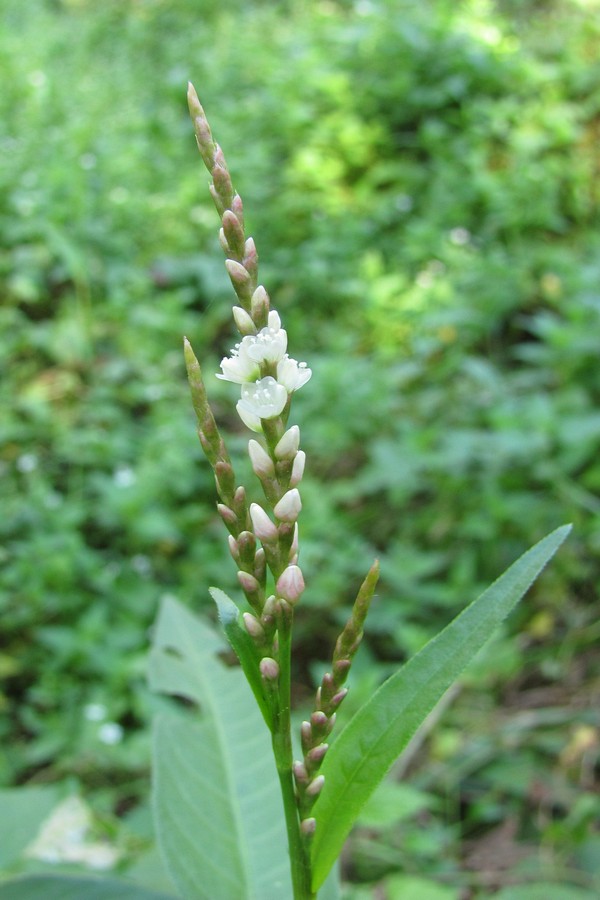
0,85,570,900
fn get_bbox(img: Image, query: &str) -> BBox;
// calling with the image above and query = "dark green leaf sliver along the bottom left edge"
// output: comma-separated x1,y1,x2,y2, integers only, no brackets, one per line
0,875,175,900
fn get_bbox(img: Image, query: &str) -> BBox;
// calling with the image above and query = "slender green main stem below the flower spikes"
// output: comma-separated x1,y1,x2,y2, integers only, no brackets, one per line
273,616,317,900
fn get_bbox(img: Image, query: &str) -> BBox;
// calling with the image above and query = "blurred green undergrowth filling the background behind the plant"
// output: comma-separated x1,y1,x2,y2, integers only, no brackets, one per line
0,0,600,900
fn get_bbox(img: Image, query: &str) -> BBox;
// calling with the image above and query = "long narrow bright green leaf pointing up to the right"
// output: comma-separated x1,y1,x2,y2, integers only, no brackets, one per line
312,525,571,891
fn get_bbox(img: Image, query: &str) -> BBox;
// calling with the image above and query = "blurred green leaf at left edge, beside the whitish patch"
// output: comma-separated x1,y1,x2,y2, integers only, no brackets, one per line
0,785,64,868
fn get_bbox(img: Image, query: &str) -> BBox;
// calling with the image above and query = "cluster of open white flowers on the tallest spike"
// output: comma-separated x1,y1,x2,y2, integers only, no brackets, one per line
217,310,312,432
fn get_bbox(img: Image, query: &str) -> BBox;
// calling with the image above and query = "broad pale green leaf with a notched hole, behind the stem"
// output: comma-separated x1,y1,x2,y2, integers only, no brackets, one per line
149,598,292,900
